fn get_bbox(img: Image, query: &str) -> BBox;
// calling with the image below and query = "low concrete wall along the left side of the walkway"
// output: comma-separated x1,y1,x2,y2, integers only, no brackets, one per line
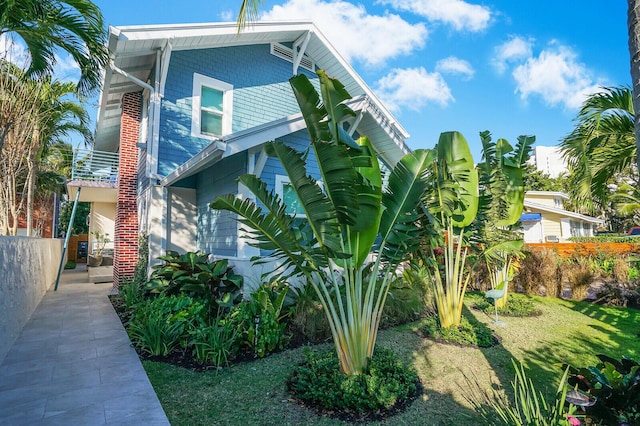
0,236,63,364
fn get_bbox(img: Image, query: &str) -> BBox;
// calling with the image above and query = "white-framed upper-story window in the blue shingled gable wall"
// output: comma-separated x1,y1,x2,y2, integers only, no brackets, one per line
191,73,233,139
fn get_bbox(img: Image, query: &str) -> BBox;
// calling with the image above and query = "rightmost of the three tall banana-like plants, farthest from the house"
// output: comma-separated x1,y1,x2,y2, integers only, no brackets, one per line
475,131,535,307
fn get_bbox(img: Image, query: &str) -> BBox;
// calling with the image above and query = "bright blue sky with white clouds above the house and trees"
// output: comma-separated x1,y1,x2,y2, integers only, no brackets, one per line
43,0,631,161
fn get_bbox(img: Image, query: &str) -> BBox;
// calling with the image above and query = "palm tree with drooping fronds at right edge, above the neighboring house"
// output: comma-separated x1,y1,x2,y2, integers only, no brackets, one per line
560,87,637,214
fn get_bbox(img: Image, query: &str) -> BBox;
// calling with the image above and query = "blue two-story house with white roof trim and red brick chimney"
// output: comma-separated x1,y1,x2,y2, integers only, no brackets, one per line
68,22,408,286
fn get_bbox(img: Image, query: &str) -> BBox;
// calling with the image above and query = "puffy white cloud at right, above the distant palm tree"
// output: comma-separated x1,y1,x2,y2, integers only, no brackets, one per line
513,43,599,109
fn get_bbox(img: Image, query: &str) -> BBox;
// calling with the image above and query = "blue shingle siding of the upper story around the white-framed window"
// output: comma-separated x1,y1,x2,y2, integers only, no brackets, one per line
158,44,317,176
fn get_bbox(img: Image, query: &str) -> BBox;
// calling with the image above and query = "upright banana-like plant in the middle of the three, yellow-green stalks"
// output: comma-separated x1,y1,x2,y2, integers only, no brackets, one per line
424,132,478,328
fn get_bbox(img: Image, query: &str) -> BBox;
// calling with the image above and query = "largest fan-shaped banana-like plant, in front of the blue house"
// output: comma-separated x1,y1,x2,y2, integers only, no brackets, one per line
211,70,434,374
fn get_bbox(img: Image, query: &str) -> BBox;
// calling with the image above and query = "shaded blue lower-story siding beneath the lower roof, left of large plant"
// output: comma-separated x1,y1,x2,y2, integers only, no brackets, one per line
194,152,247,256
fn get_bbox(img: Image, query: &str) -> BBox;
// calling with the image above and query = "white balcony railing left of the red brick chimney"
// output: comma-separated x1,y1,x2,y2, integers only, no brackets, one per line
71,148,119,184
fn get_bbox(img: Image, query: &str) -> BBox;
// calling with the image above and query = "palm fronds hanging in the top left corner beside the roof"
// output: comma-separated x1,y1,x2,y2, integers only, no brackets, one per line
0,0,109,94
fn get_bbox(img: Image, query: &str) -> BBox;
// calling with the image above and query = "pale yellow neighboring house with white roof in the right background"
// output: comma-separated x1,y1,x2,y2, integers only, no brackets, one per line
520,191,604,243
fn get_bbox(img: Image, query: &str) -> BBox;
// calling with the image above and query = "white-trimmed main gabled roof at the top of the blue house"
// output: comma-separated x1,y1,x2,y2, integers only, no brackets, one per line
95,21,409,163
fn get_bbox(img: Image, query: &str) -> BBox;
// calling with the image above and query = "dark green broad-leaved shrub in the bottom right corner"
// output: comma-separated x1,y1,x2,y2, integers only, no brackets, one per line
568,355,640,425
